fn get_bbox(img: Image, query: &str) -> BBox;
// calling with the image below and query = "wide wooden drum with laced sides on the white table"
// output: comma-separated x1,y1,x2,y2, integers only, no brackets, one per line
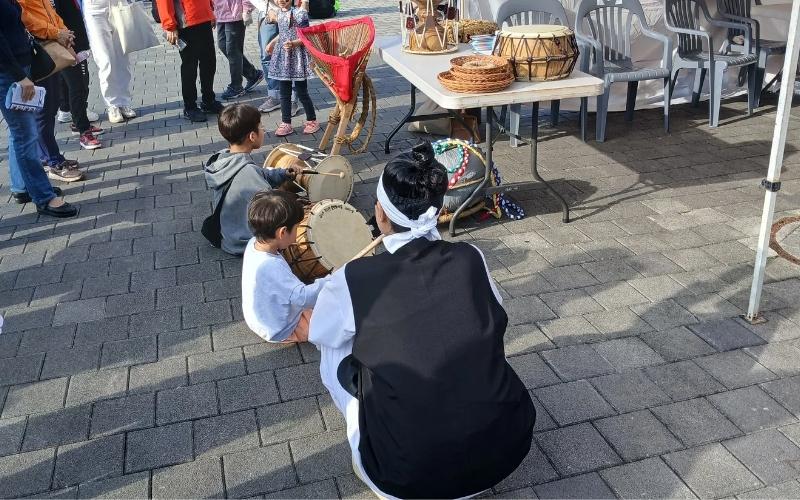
494,24,580,82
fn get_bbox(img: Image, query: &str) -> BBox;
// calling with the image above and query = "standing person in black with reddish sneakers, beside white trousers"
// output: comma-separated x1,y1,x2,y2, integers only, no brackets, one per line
53,0,103,149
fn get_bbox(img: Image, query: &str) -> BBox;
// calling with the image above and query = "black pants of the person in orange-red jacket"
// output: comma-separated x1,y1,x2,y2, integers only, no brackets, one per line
178,22,217,109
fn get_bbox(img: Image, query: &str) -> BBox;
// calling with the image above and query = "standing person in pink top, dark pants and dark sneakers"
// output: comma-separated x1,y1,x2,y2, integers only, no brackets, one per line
214,0,264,101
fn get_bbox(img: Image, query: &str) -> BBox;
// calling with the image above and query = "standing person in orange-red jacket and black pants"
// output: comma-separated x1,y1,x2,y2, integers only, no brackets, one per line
157,0,223,122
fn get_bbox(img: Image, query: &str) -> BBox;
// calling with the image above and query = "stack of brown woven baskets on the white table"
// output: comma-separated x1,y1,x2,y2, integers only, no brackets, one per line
438,56,514,94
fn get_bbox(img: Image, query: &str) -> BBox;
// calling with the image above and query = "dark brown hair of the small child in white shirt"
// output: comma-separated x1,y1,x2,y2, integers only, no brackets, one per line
247,190,305,241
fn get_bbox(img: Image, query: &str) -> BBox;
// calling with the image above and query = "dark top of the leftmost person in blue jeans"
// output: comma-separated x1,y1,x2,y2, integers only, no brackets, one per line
0,0,31,81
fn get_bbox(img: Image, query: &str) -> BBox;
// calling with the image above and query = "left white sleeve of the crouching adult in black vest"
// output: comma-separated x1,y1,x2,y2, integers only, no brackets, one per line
308,266,356,349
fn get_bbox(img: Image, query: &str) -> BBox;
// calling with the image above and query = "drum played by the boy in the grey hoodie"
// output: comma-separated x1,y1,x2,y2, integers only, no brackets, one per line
264,144,353,202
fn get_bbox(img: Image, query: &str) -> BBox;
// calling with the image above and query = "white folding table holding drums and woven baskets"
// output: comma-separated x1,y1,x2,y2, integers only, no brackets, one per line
378,36,603,235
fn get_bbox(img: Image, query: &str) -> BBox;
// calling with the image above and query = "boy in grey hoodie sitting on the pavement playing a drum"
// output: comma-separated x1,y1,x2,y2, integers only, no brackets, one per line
205,104,297,255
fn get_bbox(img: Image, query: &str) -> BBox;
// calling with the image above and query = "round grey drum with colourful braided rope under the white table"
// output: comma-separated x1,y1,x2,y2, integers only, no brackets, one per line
433,139,486,214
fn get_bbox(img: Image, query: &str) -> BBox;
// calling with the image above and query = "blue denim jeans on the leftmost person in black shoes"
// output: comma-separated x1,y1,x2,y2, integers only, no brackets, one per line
0,68,57,206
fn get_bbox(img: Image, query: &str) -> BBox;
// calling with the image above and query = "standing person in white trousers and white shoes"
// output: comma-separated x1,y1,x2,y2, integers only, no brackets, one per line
83,0,136,123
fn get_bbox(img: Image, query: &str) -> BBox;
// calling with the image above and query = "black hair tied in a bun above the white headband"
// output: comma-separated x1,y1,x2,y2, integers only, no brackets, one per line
383,141,447,232
